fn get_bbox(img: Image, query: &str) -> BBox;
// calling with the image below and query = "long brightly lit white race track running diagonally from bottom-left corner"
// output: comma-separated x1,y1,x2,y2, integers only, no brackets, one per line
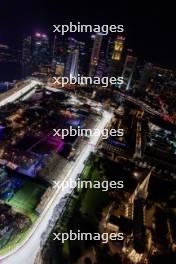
0,106,112,264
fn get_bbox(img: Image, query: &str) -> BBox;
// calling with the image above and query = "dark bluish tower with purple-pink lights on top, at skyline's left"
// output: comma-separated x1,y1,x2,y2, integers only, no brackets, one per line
32,33,50,66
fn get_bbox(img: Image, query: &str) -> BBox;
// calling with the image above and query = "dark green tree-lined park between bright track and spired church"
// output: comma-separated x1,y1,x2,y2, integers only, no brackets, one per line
43,155,109,263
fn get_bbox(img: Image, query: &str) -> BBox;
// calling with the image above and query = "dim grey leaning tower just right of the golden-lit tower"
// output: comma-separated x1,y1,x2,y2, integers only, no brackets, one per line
120,55,137,90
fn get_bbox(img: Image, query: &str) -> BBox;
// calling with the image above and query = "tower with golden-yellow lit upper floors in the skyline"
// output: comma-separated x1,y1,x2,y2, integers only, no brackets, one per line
107,36,125,77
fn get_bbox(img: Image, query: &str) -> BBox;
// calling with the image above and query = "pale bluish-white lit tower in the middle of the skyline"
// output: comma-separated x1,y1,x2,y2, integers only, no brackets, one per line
64,48,79,78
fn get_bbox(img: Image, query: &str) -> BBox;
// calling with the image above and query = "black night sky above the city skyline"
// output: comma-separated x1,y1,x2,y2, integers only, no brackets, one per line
0,0,176,68
